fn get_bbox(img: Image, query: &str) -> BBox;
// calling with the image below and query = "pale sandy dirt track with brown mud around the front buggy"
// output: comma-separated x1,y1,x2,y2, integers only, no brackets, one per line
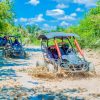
0,47,100,100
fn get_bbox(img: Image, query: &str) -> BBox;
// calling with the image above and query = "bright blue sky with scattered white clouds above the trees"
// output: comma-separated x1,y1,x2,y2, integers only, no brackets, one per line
14,0,97,30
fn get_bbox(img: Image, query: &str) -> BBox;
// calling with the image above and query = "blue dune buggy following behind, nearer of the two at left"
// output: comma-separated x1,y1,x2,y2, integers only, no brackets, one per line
4,36,26,58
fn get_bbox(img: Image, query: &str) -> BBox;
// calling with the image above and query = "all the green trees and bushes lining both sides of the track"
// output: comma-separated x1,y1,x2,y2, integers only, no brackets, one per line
0,0,100,47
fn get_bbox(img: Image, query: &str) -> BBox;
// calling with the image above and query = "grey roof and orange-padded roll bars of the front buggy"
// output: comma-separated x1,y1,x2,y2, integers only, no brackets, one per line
38,32,84,58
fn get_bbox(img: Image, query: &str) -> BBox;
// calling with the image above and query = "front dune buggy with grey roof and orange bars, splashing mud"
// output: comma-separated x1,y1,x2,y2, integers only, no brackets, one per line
38,32,94,72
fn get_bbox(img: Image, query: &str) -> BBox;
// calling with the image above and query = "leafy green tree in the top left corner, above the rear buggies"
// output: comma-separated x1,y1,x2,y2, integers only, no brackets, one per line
0,0,14,34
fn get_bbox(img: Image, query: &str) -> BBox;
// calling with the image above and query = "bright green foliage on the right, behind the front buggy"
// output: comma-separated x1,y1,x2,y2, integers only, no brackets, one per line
66,2,100,48
